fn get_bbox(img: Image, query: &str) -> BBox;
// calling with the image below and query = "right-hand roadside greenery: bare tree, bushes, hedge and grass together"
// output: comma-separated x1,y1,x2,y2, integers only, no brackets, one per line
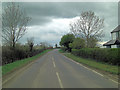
60,11,120,74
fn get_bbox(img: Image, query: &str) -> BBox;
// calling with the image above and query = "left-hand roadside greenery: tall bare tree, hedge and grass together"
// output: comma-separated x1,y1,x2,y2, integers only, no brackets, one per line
0,2,53,75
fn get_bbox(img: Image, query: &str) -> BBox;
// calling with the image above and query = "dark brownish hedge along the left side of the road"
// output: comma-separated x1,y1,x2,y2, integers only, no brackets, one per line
2,44,47,65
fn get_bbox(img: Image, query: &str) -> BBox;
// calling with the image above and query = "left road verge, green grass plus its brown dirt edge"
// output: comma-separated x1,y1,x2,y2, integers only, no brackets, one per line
2,49,52,84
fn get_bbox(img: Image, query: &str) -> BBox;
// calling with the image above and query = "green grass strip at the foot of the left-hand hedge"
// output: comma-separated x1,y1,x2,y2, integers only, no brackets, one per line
2,49,52,75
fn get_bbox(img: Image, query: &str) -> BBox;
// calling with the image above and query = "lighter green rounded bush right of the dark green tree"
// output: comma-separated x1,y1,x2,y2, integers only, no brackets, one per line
69,38,85,49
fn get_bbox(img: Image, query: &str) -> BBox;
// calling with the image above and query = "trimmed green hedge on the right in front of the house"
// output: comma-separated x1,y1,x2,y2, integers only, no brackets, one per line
72,48,120,65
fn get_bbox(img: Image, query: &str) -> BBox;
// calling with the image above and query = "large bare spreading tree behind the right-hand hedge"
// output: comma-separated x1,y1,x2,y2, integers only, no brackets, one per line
70,11,104,47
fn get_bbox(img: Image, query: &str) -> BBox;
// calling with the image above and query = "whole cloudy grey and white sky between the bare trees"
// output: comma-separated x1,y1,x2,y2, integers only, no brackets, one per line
1,2,118,45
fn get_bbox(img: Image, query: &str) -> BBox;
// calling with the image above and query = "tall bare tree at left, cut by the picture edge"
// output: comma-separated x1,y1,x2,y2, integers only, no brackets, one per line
2,2,30,48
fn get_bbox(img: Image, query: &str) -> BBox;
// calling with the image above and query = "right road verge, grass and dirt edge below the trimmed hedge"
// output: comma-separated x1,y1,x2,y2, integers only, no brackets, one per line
59,50,119,82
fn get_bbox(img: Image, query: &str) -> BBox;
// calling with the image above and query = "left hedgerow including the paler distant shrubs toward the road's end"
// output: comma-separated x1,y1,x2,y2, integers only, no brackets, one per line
2,42,52,65
